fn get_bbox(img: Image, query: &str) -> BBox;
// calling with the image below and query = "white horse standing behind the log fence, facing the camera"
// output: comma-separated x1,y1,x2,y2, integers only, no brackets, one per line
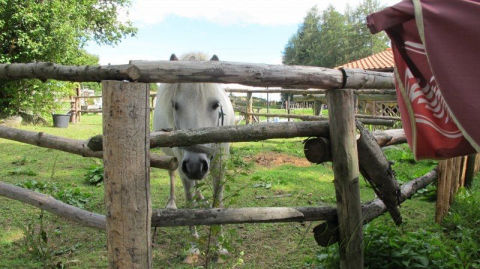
153,54,235,260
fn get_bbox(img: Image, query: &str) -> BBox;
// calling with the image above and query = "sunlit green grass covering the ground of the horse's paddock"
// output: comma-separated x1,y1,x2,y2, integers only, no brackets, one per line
0,115,480,268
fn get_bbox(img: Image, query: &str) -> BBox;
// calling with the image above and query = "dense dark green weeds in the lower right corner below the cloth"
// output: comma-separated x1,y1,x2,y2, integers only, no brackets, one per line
314,179,480,268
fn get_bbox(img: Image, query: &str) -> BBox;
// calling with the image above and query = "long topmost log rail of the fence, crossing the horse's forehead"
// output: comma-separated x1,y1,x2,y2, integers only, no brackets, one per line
0,61,394,89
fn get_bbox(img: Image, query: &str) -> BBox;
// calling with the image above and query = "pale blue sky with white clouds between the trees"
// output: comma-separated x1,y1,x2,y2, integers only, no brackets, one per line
86,0,399,100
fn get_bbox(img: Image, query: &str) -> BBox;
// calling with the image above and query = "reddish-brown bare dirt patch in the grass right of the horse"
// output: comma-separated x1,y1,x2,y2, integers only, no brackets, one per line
245,152,312,167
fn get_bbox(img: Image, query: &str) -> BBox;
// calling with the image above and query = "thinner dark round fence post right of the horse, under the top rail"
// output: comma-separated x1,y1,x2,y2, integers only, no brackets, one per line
327,89,363,268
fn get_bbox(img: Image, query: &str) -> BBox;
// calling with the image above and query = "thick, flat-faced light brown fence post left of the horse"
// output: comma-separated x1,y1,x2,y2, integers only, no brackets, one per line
102,81,152,268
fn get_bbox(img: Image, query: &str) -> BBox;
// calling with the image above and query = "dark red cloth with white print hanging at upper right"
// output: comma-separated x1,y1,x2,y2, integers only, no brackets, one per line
367,0,480,159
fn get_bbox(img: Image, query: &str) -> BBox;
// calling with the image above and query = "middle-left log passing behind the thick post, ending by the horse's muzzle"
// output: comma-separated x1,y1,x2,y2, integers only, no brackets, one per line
0,126,178,170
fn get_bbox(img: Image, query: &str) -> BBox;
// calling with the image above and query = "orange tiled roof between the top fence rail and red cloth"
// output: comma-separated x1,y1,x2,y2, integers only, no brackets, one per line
337,48,395,72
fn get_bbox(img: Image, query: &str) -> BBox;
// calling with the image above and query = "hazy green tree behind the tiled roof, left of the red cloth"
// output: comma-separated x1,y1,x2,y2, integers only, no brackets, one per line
283,0,388,71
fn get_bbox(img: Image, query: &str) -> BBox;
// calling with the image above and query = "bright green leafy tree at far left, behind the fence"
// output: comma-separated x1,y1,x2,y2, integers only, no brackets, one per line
0,0,136,117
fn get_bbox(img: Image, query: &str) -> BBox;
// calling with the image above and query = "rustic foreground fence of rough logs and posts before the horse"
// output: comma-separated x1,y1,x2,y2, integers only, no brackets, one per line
0,61,472,268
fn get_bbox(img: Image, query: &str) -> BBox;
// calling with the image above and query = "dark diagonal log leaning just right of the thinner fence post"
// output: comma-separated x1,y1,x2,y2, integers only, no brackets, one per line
356,121,402,225
